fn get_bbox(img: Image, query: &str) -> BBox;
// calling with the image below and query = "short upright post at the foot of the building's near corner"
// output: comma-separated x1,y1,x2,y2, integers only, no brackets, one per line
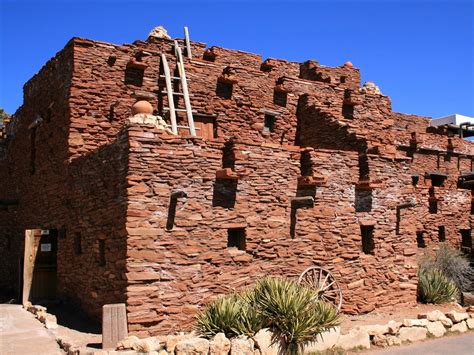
102,303,128,349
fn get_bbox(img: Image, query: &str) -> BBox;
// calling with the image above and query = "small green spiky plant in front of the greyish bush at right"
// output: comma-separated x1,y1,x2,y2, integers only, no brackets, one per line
417,268,458,303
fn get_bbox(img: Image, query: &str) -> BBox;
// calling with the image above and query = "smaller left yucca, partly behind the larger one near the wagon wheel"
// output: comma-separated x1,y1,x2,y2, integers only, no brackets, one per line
197,294,264,338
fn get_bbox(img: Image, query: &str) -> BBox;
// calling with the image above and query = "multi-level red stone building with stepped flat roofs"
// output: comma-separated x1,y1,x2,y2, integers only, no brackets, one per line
0,29,474,334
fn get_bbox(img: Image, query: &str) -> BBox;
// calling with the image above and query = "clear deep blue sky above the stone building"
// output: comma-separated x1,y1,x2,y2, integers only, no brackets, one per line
0,0,474,117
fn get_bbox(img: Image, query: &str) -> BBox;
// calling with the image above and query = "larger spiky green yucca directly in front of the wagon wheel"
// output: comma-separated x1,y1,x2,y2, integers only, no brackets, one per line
254,278,339,354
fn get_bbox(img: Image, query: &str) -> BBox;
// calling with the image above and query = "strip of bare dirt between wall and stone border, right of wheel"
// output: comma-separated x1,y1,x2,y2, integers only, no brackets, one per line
341,303,464,334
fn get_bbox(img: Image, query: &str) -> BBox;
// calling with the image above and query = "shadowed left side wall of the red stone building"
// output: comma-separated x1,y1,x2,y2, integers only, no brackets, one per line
0,42,128,317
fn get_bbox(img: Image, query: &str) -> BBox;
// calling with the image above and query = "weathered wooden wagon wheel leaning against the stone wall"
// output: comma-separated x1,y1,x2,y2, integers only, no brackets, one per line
298,266,342,310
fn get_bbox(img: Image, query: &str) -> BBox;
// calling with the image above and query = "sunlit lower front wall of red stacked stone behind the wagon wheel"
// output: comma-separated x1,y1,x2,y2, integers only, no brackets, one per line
123,127,416,333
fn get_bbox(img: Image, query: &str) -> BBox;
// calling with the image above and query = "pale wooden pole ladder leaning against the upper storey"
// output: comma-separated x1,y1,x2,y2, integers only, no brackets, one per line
160,36,196,137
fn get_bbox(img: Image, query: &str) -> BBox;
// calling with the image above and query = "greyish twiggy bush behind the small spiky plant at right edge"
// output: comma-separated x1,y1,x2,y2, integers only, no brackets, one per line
418,244,474,291
